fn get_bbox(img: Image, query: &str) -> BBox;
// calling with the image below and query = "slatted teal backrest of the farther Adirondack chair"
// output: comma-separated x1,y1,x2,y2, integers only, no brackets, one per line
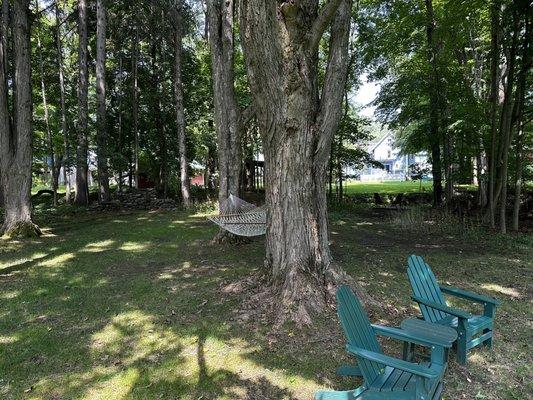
407,255,447,322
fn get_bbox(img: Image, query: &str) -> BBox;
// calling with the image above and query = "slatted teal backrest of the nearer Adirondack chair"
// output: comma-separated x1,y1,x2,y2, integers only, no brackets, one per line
337,286,385,384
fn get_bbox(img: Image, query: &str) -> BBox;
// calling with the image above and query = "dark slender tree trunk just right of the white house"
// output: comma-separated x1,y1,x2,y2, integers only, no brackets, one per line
425,0,444,206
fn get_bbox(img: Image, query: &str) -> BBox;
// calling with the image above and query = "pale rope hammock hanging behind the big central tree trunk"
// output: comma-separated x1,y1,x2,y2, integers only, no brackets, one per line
208,194,266,236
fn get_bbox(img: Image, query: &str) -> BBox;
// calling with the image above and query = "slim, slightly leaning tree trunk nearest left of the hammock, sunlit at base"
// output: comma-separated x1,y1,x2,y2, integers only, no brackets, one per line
174,18,191,207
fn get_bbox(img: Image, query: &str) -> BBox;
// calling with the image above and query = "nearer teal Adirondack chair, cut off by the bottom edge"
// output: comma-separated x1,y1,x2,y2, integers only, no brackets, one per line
315,286,451,400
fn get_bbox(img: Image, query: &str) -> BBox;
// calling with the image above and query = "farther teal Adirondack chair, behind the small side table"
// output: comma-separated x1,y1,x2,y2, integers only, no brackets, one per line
407,255,501,364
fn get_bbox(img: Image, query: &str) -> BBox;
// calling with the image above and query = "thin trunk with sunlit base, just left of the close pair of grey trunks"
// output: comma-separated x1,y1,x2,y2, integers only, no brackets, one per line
55,1,71,204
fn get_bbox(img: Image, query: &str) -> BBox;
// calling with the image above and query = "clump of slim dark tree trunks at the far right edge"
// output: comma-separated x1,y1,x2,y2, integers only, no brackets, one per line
488,0,533,233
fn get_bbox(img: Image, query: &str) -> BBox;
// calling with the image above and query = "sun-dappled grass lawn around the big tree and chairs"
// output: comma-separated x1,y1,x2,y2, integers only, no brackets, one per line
0,211,533,400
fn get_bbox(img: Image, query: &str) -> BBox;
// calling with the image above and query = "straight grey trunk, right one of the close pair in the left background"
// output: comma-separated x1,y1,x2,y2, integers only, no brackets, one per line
96,0,110,203
